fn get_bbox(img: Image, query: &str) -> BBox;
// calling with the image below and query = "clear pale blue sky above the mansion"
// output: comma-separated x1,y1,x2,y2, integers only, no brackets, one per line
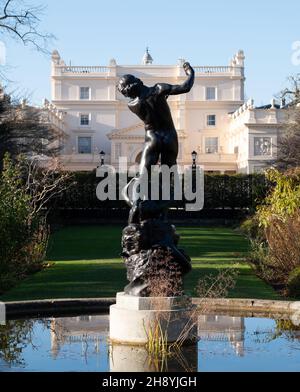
0,0,300,104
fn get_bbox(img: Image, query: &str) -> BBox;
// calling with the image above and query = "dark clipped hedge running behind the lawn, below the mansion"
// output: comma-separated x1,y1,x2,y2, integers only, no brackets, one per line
52,171,270,212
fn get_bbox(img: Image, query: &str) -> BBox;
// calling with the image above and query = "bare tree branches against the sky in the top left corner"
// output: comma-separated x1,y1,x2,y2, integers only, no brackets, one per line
0,0,54,53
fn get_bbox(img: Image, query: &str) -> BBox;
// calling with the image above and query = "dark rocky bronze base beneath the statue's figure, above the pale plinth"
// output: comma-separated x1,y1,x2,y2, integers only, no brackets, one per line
122,219,191,297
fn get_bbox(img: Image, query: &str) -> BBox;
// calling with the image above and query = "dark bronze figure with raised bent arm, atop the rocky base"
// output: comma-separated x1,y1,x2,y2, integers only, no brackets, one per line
118,63,195,223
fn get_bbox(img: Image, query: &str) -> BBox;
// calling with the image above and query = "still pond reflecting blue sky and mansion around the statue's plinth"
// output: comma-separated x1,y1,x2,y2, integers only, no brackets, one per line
0,314,300,372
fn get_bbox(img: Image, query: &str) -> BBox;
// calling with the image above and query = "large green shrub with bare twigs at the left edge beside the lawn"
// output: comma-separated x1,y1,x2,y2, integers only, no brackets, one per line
0,155,70,293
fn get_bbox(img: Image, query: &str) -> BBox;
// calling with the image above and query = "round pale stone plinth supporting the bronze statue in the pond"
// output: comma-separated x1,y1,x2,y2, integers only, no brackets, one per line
110,293,197,345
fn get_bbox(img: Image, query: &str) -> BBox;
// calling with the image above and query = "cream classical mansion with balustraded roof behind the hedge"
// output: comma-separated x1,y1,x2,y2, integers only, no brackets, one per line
45,50,284,174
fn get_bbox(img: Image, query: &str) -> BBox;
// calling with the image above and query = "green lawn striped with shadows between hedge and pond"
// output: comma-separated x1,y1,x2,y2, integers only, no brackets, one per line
0,226,279,301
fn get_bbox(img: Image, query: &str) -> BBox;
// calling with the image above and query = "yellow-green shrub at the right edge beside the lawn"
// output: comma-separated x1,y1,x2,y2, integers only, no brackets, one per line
248,168,300,285
